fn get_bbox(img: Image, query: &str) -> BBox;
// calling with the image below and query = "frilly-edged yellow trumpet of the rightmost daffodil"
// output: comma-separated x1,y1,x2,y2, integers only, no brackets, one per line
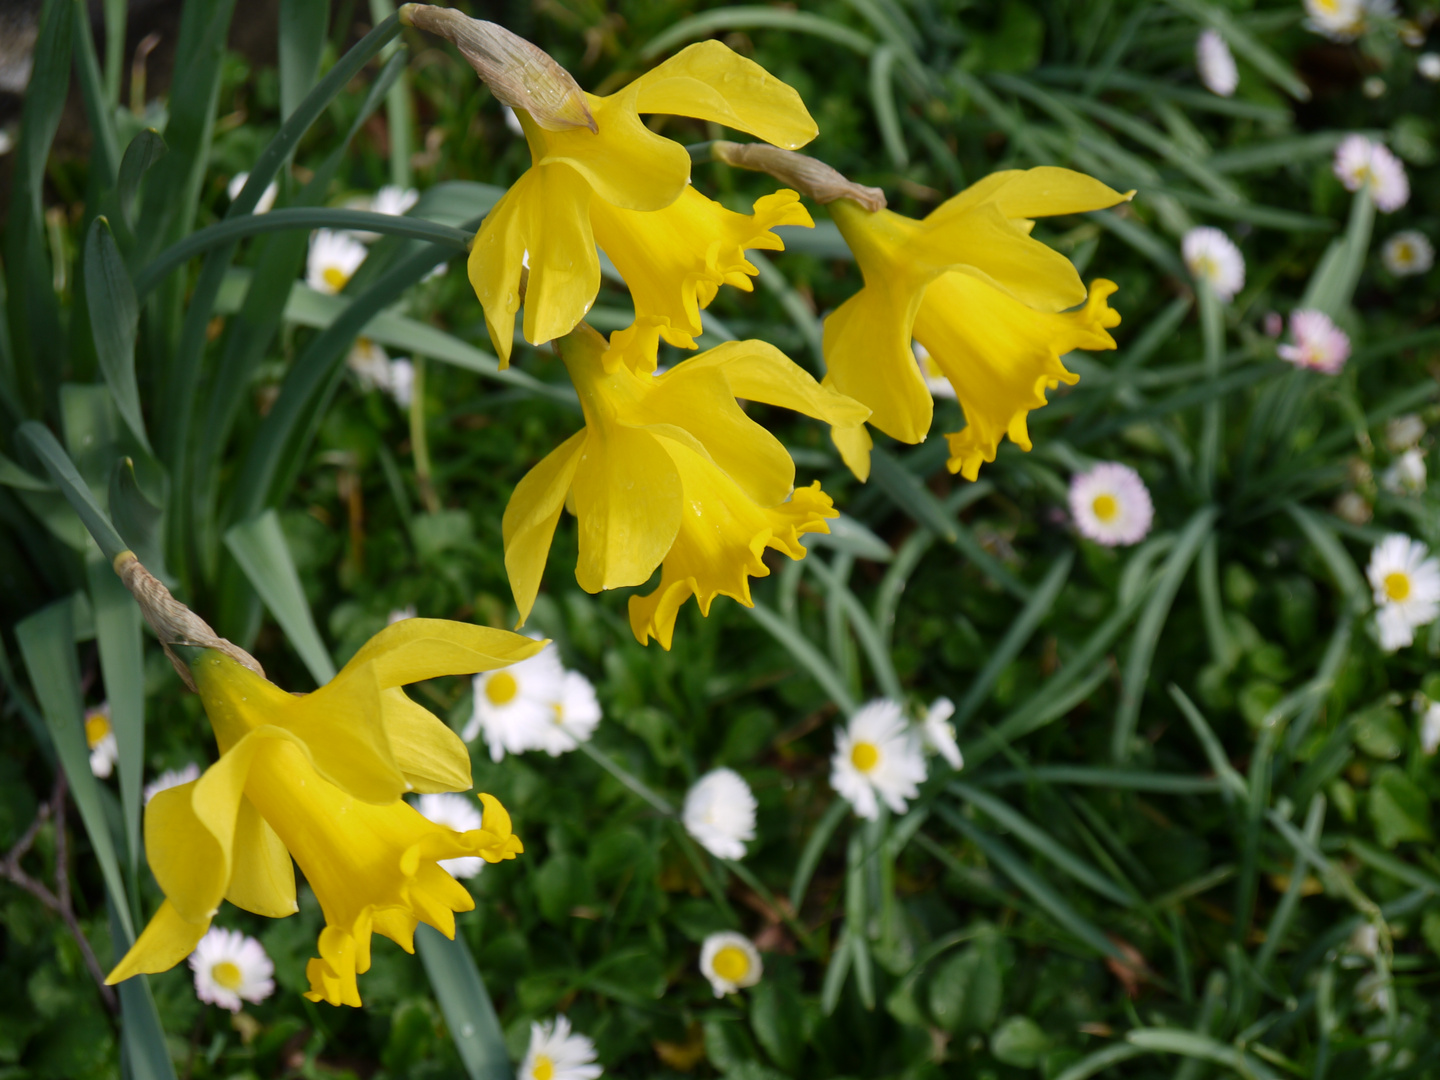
914,274,1120,480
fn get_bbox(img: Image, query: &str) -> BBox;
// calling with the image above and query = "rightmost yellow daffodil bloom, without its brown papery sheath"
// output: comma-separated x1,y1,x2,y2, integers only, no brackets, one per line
825,167,1129,480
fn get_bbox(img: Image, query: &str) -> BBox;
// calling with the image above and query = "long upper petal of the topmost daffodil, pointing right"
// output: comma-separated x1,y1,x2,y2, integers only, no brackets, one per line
631,40,819,150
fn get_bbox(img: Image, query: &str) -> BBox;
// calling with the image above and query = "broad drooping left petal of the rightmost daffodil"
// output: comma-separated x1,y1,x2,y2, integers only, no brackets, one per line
824,282,935,442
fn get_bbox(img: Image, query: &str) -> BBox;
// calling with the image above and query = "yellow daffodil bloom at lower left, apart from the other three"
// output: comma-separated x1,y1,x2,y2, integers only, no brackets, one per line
107,619,544,1005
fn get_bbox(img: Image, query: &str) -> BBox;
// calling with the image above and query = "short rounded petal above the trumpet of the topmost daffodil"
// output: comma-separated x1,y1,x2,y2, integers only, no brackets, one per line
535,84,690,213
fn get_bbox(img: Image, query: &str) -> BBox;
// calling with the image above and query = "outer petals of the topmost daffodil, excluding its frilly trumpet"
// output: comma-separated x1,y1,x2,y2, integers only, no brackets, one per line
469,42,816,364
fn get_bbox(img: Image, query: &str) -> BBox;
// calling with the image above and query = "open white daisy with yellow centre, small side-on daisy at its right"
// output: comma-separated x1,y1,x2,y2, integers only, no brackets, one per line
829,698,926,821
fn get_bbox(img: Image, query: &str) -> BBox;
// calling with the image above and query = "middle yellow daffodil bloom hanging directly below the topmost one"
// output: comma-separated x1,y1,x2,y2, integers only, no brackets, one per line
504,324,868,649
